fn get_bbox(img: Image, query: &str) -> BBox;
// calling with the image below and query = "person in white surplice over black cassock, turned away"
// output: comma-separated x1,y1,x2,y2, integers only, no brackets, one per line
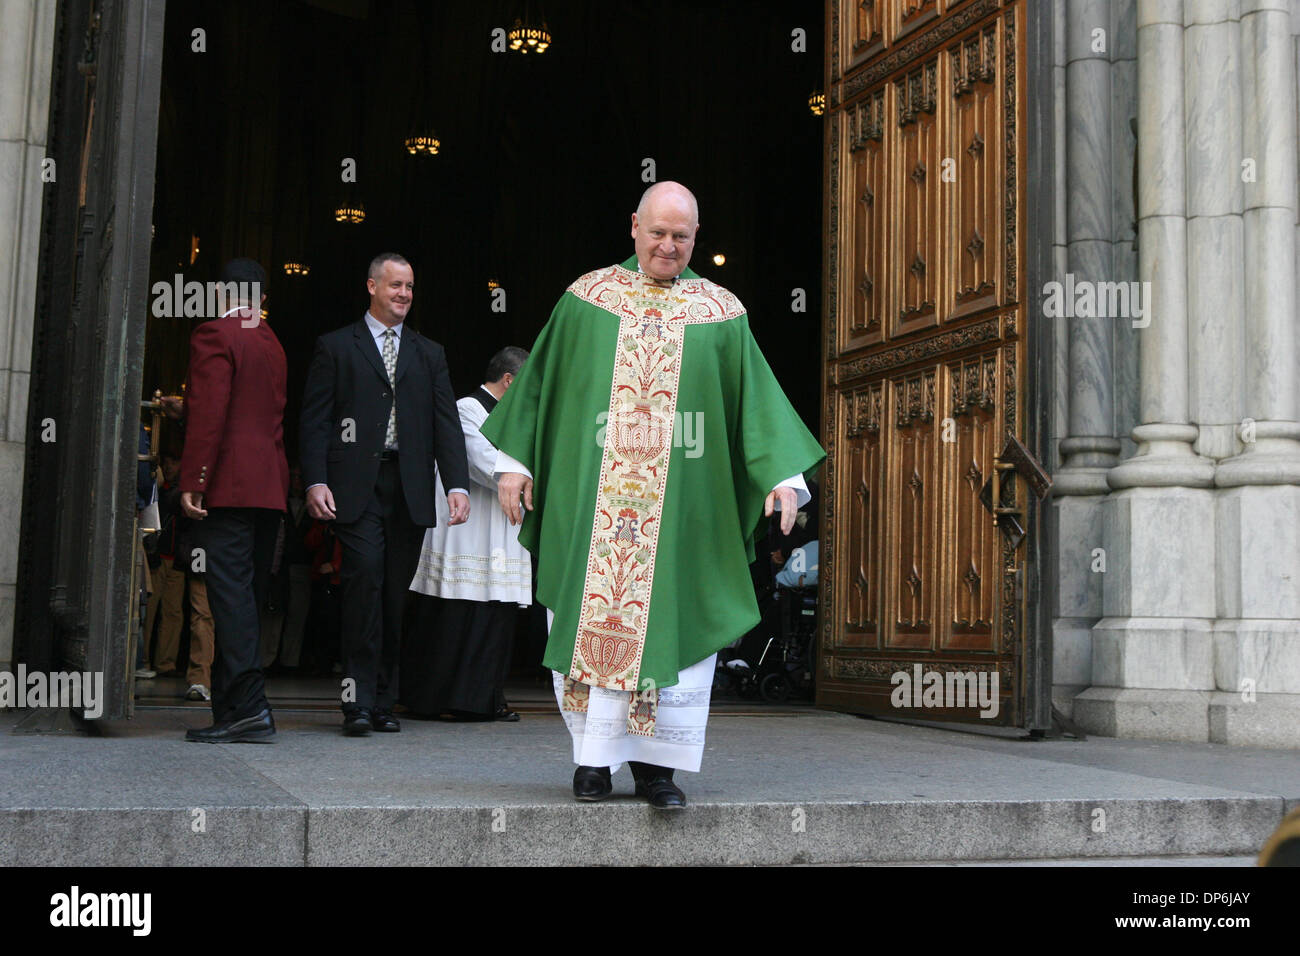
402,346,533,721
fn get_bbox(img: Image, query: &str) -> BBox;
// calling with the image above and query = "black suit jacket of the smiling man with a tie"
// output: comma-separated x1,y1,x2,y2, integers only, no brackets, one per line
300,319,469,528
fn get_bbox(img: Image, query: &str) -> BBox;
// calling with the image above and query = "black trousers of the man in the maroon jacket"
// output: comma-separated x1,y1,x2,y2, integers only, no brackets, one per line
192,507,282,723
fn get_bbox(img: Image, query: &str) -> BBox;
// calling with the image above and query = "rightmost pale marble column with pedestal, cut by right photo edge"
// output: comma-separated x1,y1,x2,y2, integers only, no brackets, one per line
1210,0,1300,747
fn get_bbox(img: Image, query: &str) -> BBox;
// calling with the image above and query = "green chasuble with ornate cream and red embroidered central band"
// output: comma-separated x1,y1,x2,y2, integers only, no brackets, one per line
482,256,826,734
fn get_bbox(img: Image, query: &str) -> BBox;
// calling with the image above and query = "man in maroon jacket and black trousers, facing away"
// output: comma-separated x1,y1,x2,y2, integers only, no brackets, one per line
181,259,289,744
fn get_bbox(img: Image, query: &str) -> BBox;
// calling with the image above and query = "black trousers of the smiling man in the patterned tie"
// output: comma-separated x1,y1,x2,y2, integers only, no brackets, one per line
334,458,424,713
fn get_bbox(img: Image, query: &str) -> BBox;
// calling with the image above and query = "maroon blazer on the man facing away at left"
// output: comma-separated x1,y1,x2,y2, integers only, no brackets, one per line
181,312,289,511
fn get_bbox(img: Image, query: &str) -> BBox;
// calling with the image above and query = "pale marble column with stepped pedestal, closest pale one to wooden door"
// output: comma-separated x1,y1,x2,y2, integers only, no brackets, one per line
1074,0,1227,740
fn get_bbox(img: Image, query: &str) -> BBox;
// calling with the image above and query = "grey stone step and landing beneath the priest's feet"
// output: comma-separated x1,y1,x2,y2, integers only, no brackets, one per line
0,710,1300,866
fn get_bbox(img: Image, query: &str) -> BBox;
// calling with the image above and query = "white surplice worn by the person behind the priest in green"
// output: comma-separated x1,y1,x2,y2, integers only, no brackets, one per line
411,397,533,607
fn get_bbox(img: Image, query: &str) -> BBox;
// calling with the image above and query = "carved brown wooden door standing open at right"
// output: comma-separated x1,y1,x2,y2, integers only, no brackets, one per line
816,0,1032,724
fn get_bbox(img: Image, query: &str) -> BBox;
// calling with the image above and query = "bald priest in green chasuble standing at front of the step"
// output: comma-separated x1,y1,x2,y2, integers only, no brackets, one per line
482,182,826,809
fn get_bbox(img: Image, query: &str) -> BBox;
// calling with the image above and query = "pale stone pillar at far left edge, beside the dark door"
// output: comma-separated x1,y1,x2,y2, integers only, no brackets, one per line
0,0,55,670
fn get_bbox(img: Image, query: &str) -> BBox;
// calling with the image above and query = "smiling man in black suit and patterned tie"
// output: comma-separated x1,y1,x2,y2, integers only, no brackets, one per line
302,252,469,736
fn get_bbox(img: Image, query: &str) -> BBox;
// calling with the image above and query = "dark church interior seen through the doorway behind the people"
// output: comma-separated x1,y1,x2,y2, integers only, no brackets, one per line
143,0,823,697
